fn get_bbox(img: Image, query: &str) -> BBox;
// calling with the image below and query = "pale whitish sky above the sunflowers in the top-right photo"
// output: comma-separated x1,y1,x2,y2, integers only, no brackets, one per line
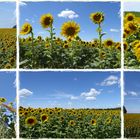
123,2,140,12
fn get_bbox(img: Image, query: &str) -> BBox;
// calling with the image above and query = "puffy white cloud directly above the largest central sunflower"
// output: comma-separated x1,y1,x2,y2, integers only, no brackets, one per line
58,9,79,19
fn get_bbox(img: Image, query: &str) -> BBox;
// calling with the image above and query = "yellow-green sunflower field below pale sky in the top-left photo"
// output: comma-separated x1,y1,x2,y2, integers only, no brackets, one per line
0,28,16,69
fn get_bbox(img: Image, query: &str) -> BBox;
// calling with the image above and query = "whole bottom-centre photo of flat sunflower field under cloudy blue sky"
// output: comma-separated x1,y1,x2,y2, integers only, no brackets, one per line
19,71,121,139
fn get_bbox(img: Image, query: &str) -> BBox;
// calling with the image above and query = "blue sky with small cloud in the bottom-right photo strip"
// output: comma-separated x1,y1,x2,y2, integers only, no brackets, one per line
124,72,140,113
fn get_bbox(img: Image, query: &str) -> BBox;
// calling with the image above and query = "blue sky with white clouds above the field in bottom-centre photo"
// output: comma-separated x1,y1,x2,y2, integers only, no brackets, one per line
19,72,120,108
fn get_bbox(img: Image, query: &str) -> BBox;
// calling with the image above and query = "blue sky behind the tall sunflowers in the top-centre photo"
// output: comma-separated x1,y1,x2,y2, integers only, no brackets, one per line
20,2,121,41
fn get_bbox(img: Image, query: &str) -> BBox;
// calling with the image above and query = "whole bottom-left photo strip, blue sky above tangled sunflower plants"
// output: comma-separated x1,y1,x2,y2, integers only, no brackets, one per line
0,72,16,139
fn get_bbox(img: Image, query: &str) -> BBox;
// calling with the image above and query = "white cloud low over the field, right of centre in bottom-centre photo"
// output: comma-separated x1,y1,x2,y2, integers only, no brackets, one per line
80,88,101,100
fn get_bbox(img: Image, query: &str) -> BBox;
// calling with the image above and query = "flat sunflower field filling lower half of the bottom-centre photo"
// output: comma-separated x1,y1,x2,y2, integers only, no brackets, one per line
19,107,121,138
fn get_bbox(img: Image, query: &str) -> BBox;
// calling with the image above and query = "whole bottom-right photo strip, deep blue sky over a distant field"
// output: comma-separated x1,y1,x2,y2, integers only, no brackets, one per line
124,71,140,139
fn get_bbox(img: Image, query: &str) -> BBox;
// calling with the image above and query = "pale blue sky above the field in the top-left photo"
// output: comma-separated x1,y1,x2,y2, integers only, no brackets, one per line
0,2,16,28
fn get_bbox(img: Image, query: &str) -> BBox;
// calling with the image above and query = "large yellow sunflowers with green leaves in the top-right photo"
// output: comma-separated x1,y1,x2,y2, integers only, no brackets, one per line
123,12,140,69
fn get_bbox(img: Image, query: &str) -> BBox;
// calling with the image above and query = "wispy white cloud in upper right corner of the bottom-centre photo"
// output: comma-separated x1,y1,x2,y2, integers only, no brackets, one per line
101,75,120,86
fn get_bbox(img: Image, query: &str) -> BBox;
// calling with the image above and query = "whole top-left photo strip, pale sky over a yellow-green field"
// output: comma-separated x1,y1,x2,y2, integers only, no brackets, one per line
0,2,17,69
